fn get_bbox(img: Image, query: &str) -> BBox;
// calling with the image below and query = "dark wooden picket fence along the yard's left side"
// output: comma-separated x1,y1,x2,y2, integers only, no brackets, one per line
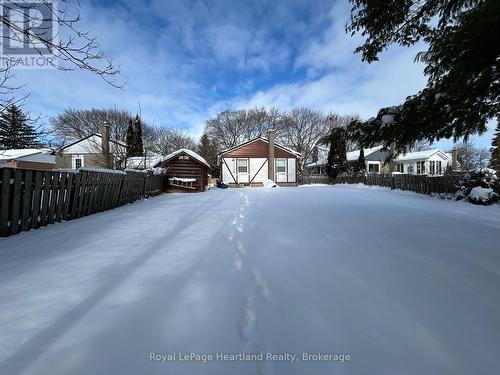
0,168,162,237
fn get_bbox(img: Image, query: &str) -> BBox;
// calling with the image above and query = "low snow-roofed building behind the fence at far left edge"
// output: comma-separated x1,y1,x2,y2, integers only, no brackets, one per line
0,148,56,170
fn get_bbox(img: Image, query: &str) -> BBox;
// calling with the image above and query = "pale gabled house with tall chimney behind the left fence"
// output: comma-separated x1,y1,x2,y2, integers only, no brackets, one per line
56,133,127,169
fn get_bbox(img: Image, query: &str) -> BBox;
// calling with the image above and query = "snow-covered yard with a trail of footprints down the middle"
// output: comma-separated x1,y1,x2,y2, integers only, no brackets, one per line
0,185,500,375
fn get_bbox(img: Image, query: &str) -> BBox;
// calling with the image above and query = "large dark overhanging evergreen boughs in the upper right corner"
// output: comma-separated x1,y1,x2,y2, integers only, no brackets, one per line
347,0,500,151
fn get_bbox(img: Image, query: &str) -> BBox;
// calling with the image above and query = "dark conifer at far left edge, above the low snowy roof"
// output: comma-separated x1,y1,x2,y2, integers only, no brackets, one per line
0,104,40,149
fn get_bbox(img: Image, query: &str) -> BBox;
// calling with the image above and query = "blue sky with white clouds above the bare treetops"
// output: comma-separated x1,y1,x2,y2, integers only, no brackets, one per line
11,0,493,147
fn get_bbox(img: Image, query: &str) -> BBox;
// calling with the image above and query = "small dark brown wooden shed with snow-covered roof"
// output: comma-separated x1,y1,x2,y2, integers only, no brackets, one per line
155,148,210,192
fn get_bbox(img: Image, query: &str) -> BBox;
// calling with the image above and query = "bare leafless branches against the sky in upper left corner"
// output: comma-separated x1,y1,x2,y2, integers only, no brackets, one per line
0,0,124,109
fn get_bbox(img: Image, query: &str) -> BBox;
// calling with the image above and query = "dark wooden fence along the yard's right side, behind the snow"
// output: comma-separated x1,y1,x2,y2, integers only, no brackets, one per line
302,174,461,194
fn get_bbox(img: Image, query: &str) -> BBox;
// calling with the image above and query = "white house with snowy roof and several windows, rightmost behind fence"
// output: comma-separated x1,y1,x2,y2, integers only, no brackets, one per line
394,149,452,175
